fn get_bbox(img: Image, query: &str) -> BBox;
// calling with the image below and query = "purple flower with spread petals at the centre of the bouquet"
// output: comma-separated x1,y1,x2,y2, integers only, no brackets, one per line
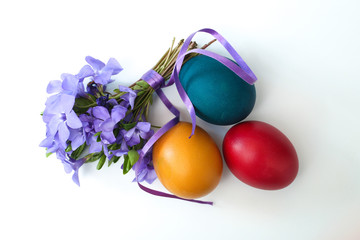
92,105,127,144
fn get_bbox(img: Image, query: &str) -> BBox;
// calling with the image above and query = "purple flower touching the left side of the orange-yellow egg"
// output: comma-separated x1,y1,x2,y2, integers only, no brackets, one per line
133,151,157,184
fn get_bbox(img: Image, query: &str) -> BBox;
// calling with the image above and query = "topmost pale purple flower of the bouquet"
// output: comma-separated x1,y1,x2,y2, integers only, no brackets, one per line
85,56,123,85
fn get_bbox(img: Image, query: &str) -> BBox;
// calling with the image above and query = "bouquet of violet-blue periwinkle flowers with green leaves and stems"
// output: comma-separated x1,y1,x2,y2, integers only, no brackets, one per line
40,40,213,185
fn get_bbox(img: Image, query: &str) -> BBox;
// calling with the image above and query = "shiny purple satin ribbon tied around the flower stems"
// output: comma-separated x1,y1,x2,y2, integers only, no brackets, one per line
136,28,257,205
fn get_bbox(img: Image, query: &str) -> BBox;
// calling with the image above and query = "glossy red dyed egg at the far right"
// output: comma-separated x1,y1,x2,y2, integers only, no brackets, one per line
223,121,299,190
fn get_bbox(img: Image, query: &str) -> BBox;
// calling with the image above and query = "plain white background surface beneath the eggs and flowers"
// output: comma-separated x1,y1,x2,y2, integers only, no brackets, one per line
0,0,360,240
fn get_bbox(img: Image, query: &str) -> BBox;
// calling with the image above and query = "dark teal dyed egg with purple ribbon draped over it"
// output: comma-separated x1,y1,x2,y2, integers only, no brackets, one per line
179,55,256,125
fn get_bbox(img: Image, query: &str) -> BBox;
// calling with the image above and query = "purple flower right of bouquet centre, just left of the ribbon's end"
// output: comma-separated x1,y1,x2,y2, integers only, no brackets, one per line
122,122,154,147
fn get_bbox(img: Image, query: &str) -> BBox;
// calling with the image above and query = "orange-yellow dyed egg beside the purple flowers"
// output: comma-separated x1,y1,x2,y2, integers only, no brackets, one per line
153,122,223,199
